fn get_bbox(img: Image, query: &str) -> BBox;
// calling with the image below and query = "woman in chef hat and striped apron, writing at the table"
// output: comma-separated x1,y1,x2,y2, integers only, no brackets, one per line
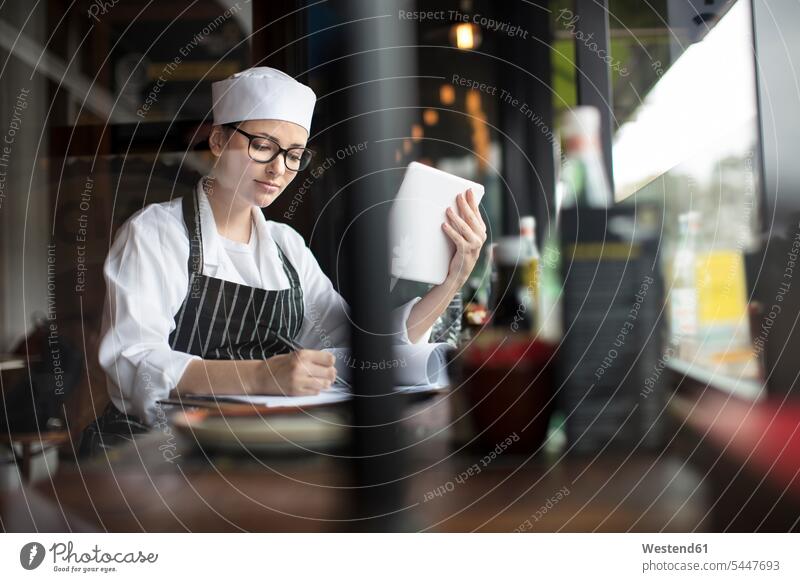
83,67,486,451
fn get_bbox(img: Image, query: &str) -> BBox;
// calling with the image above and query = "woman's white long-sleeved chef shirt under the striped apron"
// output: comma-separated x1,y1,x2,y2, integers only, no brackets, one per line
99,181,431,424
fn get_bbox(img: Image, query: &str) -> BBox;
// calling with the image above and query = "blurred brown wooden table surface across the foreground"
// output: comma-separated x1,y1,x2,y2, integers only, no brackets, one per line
0,396,707,532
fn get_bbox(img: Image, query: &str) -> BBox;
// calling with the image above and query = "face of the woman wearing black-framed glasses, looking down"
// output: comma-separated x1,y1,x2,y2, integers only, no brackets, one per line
209,119,308,208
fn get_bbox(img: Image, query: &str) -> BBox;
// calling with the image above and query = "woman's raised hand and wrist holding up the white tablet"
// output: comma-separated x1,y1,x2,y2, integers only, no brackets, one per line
442,190,486,292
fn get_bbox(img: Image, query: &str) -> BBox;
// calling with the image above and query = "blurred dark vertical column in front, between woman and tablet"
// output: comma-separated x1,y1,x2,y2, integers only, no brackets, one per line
343,0,415,531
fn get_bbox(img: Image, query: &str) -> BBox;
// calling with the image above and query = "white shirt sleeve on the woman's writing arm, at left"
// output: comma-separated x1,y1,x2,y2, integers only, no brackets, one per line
98,210,200,425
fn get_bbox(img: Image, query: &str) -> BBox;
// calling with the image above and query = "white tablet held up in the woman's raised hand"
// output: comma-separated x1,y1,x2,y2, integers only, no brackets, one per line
389,162,483,285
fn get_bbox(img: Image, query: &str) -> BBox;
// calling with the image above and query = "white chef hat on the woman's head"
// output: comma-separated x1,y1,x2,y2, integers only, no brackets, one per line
211,67,317,133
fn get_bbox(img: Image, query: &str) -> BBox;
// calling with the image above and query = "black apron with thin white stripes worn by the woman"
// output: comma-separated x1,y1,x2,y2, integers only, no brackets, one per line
80,192,304,456
